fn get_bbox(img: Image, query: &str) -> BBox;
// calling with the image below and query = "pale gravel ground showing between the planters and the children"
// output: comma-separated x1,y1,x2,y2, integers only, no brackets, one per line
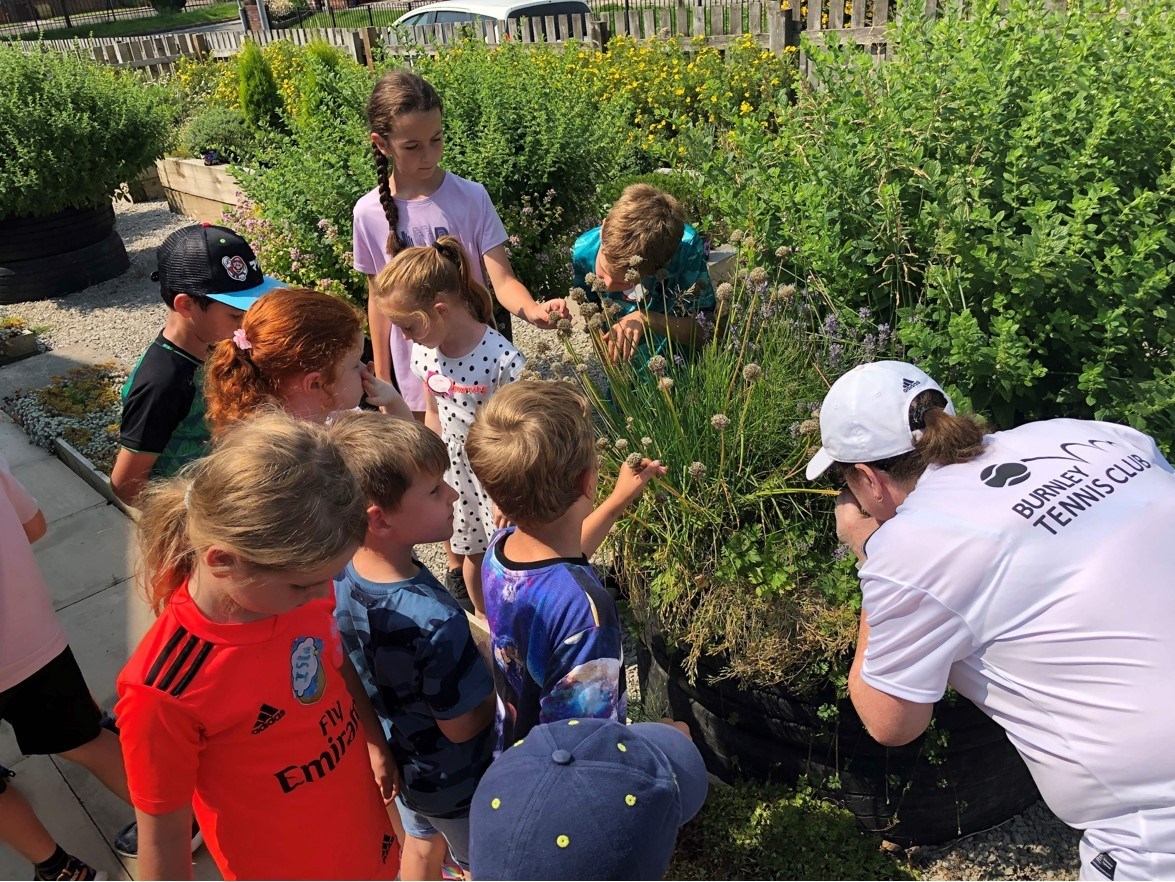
0,202,1079,880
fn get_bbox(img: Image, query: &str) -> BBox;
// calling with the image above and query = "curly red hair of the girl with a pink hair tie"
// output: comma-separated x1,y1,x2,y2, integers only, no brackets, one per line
204,288,363,437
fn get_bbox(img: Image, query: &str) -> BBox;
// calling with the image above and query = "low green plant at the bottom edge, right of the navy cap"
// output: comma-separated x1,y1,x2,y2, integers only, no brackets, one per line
665,781,918,880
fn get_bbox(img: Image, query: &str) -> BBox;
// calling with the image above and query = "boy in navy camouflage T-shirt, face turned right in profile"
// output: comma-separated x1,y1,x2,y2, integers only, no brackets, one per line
331,412,494,880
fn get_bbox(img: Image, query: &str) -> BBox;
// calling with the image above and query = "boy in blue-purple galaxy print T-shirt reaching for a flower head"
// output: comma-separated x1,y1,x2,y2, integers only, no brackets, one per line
465,381,665,754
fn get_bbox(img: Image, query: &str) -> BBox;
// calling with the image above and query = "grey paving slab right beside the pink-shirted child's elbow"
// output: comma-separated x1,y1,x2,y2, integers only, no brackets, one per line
29,502,136,610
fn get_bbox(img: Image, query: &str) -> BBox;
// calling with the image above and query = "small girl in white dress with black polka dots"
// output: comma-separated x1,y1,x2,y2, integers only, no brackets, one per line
371,236,525,618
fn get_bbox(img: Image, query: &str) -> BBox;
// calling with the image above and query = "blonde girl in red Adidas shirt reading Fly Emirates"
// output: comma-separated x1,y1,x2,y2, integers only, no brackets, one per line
116,412,400,878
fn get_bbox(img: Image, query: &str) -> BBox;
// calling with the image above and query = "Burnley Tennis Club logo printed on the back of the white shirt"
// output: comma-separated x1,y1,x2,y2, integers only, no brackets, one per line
983,439,1154,536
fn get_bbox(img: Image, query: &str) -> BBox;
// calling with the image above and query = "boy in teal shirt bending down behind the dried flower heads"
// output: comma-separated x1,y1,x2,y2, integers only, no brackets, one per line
571,183,714,364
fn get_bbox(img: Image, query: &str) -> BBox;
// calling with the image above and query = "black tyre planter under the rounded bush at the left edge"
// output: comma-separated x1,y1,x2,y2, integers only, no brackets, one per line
0,204,130,303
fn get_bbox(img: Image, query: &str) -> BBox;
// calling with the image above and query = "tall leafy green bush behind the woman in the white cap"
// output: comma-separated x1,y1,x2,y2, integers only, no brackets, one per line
691,0,1175,451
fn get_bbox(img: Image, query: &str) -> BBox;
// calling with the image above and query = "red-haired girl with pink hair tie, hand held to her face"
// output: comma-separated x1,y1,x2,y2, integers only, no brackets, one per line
204,288,411,437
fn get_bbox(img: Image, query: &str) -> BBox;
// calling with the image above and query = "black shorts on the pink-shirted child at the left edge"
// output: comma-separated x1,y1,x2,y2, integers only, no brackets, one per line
0,646,102,754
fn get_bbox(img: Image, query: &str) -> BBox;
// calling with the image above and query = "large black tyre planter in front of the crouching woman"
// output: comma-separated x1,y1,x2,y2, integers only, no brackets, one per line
638,642,1040,846
